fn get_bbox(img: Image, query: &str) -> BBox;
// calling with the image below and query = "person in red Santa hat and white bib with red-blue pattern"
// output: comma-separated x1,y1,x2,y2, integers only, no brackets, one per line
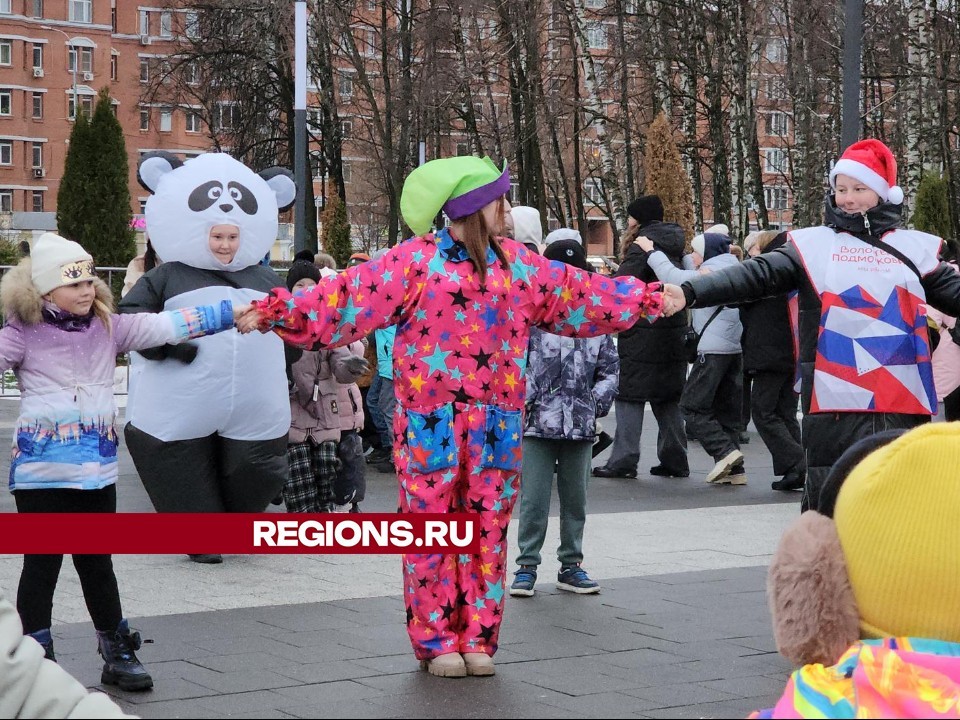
665,140,960,509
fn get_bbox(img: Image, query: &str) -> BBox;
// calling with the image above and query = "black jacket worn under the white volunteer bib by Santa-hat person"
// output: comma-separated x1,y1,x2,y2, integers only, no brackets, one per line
683,196,960,414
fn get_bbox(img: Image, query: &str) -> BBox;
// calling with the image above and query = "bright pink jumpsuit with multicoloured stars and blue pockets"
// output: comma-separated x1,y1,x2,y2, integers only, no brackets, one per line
254,230,661,660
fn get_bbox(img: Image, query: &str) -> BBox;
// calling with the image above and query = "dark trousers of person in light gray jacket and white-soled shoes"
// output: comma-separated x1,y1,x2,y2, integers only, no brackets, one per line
680,354,743,460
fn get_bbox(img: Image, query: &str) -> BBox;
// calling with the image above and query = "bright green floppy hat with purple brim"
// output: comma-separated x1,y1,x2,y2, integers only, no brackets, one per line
400,155,510,235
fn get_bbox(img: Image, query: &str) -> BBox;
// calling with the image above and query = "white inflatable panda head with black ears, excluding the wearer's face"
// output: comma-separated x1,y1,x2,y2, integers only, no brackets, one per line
138,152,297,271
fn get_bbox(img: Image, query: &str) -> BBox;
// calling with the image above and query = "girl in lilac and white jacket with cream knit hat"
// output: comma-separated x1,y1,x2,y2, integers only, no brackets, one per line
0,233,233,690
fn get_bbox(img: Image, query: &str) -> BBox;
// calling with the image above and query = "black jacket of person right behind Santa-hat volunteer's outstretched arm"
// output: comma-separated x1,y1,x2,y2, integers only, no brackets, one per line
740,233,796,373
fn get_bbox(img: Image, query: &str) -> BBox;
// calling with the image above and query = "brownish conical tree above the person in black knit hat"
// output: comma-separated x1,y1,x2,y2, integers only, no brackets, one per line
643,113,693,243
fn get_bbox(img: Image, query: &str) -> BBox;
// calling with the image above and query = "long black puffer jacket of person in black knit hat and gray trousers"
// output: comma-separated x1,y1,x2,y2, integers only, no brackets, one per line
616,222,687,402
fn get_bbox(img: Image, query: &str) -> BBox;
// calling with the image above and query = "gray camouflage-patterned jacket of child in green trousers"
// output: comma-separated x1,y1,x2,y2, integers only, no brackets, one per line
523,329,620,440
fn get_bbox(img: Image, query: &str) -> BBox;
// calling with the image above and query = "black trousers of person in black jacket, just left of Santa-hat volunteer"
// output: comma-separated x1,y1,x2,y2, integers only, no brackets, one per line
751,370,804,475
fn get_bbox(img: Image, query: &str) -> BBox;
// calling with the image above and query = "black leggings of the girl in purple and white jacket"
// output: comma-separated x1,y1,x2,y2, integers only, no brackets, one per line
13,485,123,633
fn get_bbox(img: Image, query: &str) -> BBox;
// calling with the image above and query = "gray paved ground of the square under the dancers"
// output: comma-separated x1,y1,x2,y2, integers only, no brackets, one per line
0,399,799,718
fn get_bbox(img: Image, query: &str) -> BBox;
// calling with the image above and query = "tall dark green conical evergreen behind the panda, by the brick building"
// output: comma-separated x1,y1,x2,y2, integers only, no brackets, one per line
57,88,136,282
